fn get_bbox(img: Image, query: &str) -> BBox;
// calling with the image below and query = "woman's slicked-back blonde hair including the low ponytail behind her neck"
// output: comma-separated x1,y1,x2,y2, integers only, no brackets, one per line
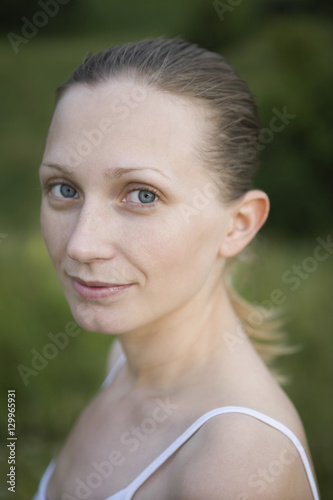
56,38,290,378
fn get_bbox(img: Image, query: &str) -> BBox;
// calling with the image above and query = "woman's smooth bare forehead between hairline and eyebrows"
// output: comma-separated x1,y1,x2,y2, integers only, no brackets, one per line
45,79,205,178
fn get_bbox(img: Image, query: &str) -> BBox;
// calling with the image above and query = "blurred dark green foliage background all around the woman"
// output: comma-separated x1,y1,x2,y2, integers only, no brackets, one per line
0,0,333,499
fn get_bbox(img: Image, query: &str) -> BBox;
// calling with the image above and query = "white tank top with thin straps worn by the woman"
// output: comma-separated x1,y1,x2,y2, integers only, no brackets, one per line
33,355,319,500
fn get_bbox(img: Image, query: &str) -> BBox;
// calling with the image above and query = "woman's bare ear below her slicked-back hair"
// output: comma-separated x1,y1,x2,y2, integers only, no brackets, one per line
219,189,269,257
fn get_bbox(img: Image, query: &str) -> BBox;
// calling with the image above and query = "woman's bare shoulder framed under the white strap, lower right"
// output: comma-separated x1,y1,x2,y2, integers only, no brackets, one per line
175,413,313,500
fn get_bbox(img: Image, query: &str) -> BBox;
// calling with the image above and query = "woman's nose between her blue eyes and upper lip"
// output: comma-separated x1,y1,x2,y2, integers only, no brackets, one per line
67,204,116,263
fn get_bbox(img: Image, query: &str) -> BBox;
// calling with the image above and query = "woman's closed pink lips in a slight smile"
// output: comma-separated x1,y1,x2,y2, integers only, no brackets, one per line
70,276,133,300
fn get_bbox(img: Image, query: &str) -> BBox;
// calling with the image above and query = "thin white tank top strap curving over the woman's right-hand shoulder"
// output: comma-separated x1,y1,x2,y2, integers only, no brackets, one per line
118,406,319,500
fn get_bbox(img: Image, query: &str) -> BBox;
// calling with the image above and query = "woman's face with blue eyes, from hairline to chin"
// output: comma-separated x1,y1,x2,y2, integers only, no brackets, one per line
40,80,228,334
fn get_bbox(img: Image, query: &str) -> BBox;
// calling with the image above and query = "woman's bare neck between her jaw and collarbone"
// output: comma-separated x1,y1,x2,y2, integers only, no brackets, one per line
118,283,240,392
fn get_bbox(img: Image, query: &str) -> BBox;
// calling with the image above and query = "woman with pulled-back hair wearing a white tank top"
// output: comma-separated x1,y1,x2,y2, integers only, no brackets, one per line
35,39,318,500
